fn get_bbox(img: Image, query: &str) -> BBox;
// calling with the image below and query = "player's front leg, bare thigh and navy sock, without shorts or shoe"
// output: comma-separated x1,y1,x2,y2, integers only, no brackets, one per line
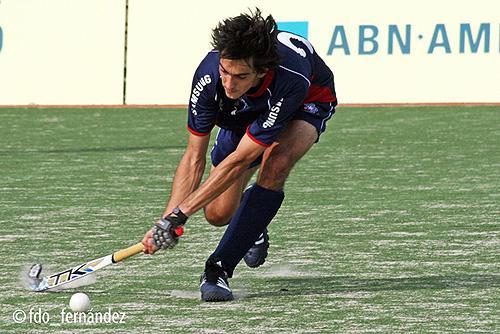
211,120,318,277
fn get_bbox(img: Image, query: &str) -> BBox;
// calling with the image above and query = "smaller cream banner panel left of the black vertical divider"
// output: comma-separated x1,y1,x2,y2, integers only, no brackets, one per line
0,0,125,105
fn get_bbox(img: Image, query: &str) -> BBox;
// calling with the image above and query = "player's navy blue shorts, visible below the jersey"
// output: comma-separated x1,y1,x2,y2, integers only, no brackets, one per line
211,102,335,168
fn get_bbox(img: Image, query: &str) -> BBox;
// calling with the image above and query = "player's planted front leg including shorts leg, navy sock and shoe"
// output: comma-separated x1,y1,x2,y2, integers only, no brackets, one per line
201,104,334,301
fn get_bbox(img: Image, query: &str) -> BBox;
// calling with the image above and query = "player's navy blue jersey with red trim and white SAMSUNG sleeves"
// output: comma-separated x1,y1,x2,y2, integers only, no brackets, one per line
188,31,337,146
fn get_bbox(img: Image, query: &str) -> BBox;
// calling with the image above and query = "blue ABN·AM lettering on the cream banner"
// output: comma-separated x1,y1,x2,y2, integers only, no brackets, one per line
327,23,500,56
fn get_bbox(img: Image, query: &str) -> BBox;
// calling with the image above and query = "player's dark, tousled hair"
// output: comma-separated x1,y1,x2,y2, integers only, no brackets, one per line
212,8,281,73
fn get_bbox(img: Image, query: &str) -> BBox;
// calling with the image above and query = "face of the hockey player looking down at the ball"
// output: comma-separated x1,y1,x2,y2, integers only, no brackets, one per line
219,58,266,99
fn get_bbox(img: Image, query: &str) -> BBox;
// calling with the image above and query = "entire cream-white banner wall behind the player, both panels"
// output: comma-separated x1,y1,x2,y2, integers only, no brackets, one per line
0,0,500,105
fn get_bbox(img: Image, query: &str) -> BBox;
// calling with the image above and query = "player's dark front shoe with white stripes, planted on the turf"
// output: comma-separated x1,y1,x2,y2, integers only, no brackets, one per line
200,258,234,302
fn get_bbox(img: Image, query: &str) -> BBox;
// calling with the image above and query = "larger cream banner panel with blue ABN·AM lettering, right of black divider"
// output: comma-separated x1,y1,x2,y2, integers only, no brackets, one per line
127,0,500,104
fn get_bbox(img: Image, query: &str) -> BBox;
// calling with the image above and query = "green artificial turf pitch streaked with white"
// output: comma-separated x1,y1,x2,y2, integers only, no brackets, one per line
0,106,500,333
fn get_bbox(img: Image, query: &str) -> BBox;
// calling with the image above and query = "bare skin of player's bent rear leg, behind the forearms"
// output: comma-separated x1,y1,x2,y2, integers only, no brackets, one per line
204,166,259,226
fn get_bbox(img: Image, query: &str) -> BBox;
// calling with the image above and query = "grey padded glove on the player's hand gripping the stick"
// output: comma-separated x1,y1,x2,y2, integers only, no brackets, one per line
151,207,188,249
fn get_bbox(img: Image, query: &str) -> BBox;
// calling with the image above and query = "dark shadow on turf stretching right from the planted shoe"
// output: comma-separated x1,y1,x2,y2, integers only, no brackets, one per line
247,275,500,298
